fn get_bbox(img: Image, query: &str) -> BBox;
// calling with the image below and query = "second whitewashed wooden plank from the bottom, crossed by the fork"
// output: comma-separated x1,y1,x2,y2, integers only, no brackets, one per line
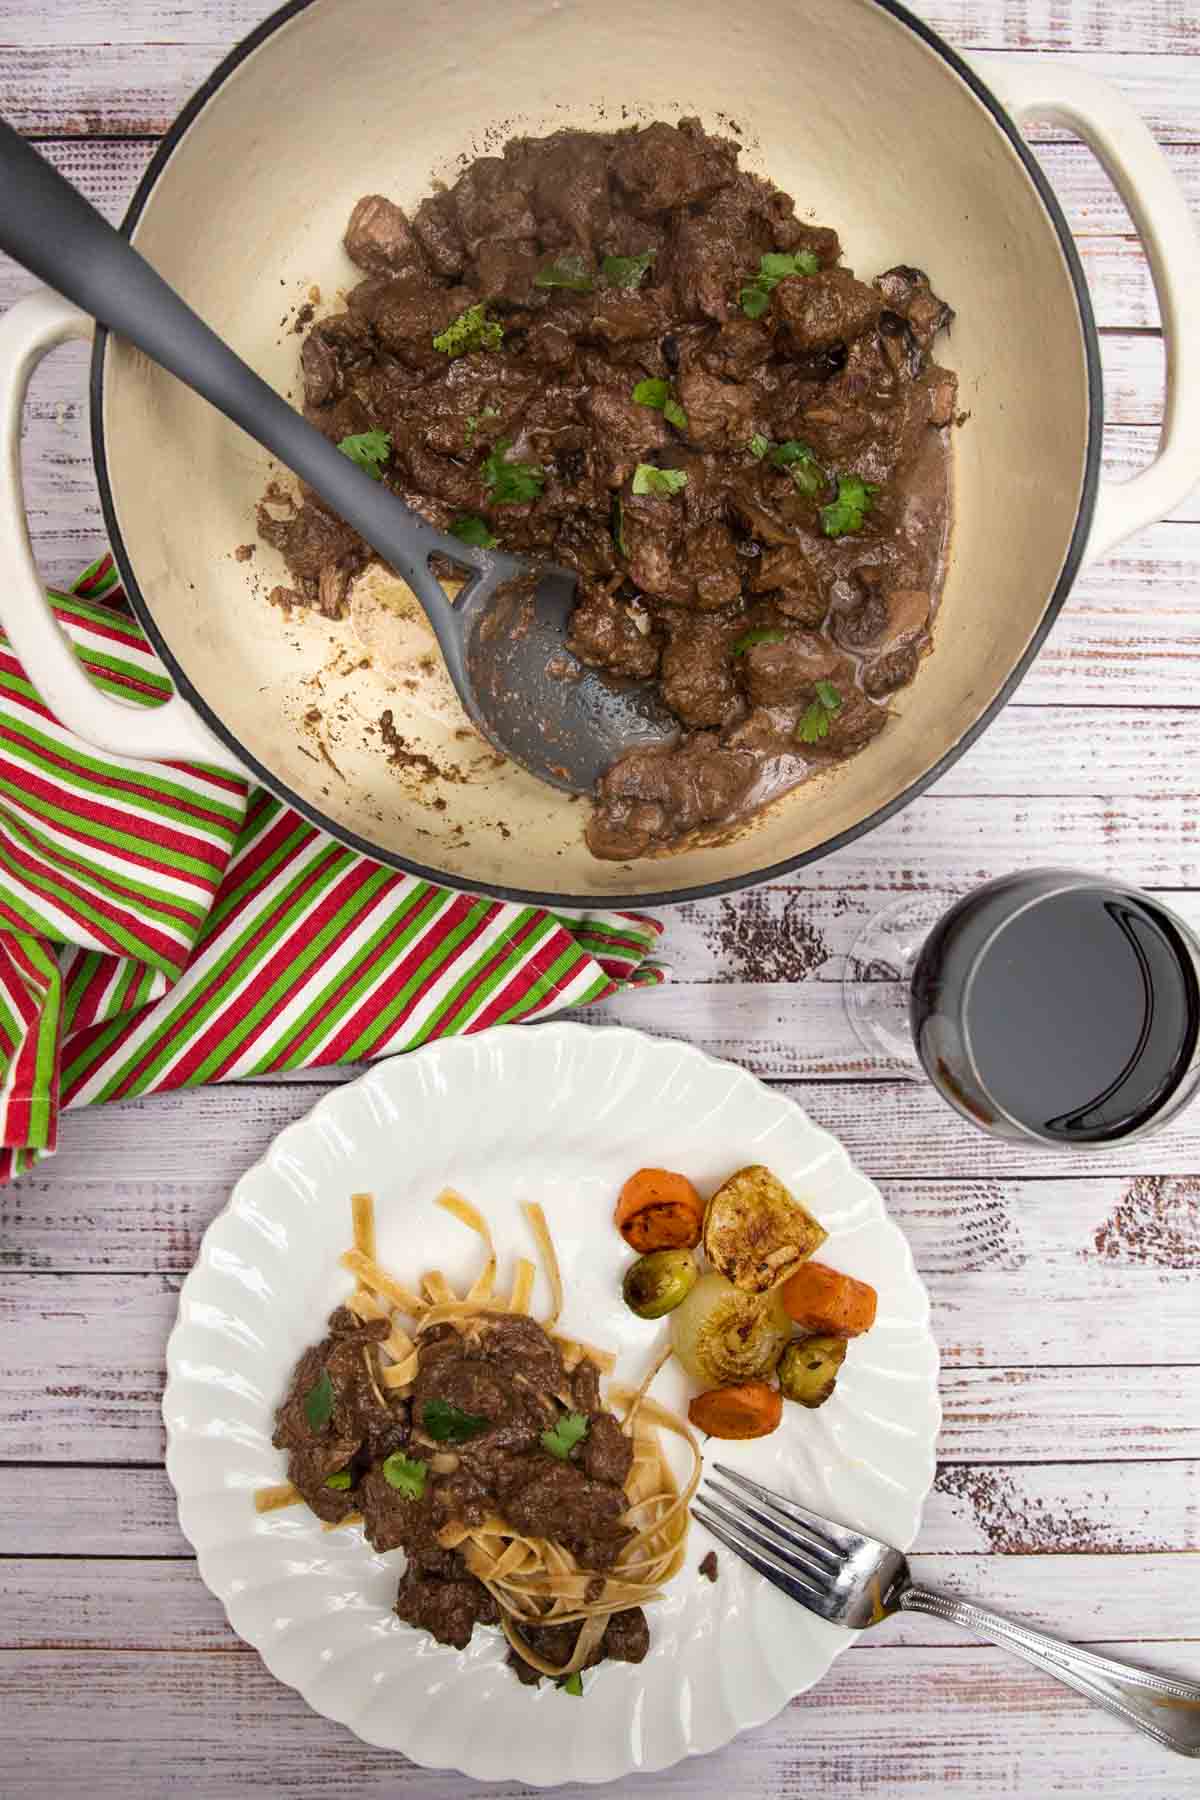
0,1553,1196,1656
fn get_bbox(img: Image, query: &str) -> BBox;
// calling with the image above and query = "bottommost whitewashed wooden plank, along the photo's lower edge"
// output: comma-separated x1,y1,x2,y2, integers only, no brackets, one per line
0,1643,1200,1800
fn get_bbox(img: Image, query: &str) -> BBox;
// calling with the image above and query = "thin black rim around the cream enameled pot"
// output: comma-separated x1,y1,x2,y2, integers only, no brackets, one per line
90,0,1105,911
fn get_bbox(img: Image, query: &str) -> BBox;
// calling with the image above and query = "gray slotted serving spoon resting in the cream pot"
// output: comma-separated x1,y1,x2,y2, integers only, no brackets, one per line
0,121,678,794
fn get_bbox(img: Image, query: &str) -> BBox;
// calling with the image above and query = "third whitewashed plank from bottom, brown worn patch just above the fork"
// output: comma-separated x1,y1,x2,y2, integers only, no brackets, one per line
0,1460,1200,1555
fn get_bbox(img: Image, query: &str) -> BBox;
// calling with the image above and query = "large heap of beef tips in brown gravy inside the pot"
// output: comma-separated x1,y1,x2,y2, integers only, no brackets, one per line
259,119,955,859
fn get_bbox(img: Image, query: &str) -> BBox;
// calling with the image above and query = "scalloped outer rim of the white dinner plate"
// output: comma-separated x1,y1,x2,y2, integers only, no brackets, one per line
160,1019,943,1787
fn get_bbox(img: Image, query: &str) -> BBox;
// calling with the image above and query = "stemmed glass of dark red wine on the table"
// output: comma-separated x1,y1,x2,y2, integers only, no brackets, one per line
846,869,1200,1148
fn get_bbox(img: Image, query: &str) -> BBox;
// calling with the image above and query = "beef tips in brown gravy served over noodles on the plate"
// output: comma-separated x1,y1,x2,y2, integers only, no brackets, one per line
273,1307,649,1681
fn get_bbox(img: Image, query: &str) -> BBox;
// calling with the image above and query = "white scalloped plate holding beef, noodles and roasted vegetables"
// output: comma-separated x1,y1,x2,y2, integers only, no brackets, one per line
164,1024,939,1786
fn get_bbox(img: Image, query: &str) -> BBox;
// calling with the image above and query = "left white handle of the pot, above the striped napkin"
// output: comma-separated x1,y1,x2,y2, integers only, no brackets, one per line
0,288,248,779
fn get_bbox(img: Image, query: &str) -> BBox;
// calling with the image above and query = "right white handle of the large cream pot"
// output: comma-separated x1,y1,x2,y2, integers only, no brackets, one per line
972,50,1200,562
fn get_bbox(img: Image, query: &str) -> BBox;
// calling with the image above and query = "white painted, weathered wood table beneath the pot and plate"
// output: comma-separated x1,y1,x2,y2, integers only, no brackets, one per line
0,0,1200,1800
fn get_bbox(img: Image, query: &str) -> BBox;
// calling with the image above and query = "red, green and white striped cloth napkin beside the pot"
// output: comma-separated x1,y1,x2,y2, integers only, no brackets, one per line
0,556,662,1181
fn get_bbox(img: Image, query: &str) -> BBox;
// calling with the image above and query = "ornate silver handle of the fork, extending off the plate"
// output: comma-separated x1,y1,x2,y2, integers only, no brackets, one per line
900,1588,1200,1757
